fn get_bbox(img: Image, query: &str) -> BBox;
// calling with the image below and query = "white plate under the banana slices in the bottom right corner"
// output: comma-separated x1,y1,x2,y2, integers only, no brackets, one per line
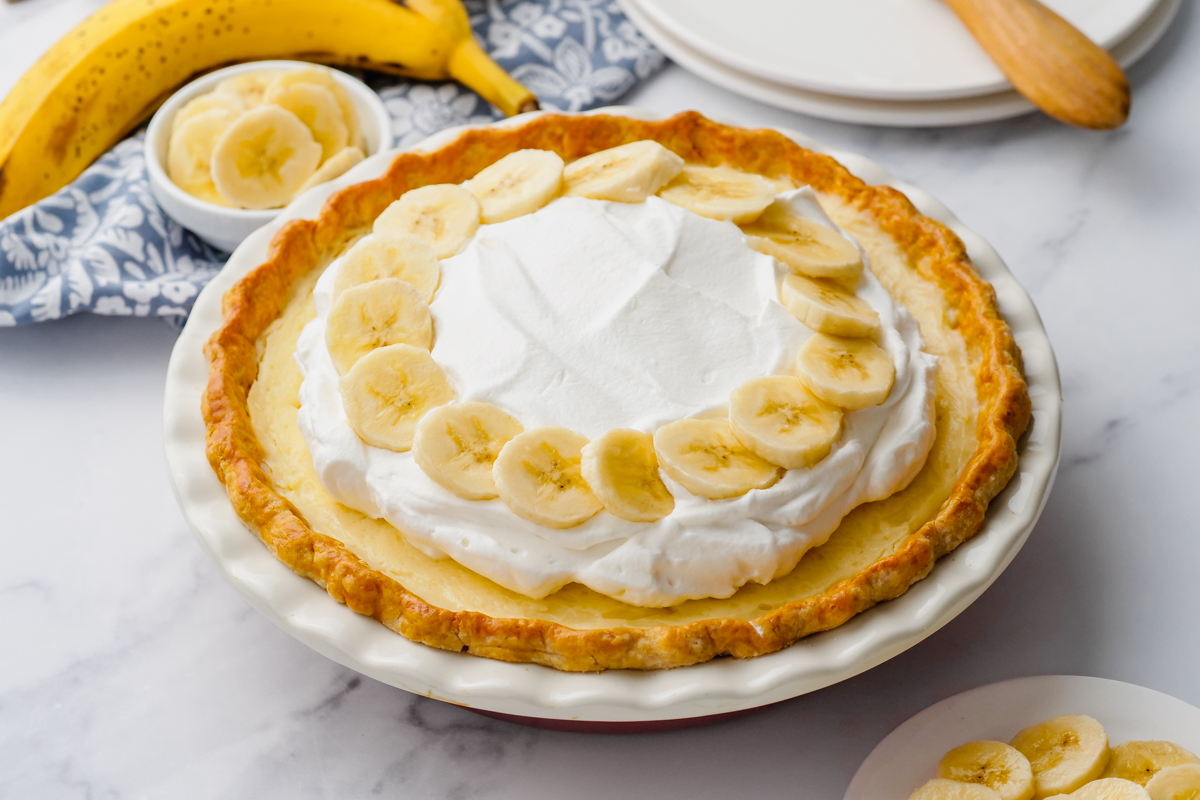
844,675,1200,800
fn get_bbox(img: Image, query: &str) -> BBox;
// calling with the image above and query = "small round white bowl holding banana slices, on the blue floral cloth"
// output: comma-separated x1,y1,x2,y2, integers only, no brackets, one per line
145,61,394,251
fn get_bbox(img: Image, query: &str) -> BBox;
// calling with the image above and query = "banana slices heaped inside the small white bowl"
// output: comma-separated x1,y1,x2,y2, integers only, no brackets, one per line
167,66,365,209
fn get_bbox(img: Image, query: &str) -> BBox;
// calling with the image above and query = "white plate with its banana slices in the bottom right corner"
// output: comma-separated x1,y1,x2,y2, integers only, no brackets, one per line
845,675,1200,800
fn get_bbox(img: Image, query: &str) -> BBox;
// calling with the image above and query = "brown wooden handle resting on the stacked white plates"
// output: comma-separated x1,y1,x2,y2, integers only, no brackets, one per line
946,0,1130,130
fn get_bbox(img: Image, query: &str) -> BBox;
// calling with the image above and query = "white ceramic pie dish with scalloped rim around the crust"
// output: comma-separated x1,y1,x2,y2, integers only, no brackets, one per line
163,108,1061,722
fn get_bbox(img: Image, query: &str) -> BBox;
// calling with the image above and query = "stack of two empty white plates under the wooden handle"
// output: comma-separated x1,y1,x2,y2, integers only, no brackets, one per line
619,0,1182,126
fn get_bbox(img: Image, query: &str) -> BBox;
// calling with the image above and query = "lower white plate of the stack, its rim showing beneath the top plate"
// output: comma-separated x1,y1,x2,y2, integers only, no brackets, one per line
618,0,1182,127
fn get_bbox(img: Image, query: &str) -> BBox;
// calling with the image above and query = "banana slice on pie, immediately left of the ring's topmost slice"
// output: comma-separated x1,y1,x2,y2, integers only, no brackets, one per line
463,150,563,225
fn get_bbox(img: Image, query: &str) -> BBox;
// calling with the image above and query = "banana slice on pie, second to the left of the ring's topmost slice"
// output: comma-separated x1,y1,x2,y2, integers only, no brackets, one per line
374,184,480,258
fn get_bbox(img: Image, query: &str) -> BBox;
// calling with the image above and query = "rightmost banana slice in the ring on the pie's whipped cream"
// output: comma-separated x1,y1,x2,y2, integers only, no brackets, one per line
796,333,896,411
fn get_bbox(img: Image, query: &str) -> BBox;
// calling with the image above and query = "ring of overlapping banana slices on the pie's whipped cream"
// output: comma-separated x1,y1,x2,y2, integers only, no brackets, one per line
325,139,895,528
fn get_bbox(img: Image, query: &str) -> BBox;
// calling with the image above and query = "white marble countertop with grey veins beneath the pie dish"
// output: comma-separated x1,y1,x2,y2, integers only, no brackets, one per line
0,0,1200,800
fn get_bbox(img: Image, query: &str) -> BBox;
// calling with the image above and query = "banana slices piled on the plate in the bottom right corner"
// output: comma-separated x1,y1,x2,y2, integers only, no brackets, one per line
908,715,1200,800
